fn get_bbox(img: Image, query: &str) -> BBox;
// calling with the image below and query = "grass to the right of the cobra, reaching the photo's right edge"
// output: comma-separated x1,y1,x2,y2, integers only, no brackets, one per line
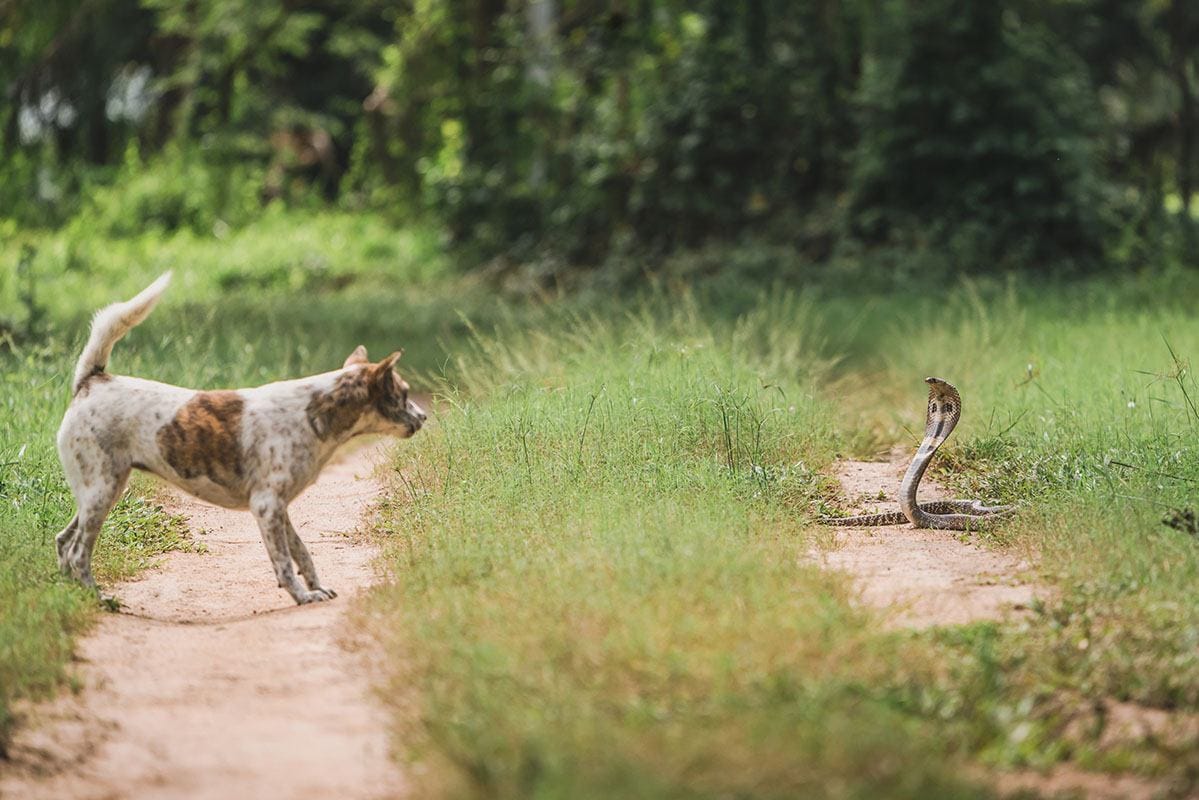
848,276,1199,792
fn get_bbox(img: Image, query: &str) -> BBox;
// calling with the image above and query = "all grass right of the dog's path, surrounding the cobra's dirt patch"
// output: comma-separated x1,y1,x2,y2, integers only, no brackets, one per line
374,273,1199,798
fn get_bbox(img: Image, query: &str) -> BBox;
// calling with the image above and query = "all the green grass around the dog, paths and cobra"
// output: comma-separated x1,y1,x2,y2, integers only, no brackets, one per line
0,212,1199,798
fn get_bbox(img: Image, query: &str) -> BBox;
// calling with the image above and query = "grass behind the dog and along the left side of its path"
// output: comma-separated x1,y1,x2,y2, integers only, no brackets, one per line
0,213,496,752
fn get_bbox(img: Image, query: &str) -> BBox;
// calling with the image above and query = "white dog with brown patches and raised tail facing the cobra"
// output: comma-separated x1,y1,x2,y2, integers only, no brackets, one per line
55,272,426,603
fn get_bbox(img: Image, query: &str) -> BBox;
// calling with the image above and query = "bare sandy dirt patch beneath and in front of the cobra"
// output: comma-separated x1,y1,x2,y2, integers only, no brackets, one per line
812,451,1035,627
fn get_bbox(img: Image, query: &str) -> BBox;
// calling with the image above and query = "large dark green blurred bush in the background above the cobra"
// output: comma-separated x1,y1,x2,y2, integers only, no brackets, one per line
851,0,1104,271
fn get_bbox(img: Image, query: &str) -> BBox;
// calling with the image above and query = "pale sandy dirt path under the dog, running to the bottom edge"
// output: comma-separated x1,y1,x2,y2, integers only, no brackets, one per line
0,445,402,800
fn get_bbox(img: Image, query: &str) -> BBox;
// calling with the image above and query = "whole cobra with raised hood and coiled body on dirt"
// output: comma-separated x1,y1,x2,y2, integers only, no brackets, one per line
819,378,1016,530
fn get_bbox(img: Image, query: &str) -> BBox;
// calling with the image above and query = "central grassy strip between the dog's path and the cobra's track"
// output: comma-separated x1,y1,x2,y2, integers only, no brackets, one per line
373,297,1002,798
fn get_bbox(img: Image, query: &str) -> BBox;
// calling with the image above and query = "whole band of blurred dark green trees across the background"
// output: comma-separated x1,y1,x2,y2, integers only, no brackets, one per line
0,0,1199,273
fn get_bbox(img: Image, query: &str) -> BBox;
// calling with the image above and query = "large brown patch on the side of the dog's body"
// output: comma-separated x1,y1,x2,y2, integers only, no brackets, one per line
157,391,246,488
